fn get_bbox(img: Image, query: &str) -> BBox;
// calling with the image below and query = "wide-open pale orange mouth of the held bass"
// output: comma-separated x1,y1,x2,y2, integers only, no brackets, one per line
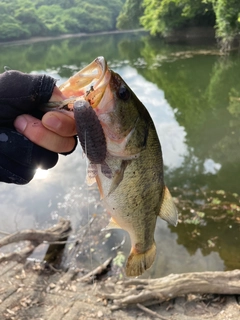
59,57,111,109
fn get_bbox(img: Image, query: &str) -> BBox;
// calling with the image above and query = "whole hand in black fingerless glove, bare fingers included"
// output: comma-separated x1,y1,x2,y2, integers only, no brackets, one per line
0,71,77,184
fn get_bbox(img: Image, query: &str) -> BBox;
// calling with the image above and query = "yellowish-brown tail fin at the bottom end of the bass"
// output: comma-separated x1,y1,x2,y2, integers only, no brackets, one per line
126,242,156,277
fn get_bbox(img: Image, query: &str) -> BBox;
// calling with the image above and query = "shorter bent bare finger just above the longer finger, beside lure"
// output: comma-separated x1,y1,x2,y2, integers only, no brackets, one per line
42,111,76,137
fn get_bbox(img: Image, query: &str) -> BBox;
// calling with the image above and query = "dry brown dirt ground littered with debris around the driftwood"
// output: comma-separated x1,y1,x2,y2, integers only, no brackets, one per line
0,262,240,320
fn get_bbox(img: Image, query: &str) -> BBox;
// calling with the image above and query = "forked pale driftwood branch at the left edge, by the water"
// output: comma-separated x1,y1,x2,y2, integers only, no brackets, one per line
0,219,71,263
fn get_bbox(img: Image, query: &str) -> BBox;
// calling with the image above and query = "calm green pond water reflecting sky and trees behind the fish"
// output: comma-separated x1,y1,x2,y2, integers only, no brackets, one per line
0,34,240,277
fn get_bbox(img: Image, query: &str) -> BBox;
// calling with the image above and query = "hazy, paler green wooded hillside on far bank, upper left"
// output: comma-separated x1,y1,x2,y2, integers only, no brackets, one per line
0,0,125,41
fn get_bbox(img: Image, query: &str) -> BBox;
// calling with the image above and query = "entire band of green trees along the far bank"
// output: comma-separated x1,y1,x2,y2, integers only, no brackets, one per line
0,0,240,47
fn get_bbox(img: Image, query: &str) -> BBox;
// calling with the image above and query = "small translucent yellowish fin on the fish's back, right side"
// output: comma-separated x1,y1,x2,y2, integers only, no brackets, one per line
159,186,178,227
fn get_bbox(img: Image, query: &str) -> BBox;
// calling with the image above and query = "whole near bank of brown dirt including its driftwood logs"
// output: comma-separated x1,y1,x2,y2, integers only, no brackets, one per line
0,216,240,320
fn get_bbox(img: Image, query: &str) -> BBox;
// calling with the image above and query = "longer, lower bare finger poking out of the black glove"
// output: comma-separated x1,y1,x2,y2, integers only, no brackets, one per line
14,114,76,153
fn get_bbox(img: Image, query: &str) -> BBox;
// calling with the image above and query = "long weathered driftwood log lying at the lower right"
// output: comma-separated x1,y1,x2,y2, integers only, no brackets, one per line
98,270,240,310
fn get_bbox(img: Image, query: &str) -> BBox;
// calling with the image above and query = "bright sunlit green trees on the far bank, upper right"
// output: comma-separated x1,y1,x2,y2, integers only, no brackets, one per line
117,0,240,48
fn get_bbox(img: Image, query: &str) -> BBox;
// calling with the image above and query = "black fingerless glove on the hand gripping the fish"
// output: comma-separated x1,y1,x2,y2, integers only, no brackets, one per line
0,70,58,184
